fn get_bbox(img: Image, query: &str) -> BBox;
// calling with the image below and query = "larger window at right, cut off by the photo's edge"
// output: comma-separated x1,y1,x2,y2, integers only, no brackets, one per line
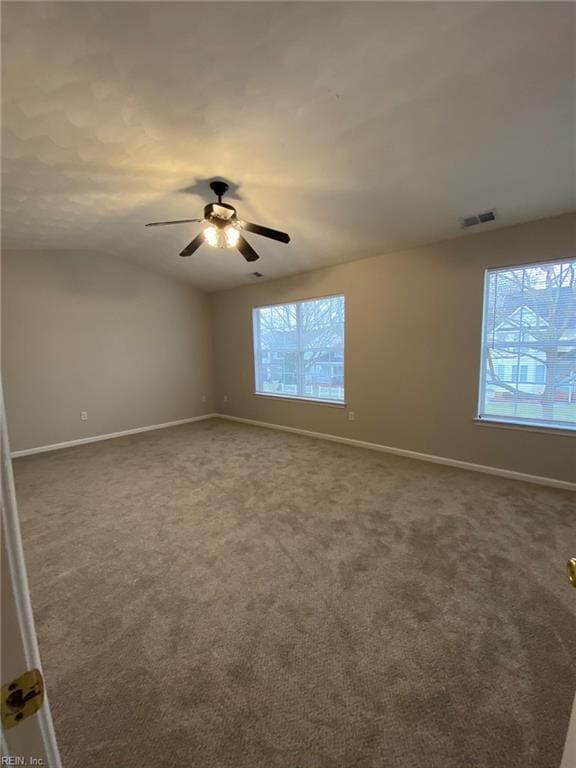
478,260,576,429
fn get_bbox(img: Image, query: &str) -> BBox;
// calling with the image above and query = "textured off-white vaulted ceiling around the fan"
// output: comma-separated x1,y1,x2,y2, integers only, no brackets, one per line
2,2,575,290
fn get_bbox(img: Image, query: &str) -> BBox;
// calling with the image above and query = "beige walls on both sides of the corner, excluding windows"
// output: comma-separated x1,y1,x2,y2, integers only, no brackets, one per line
2,215,576,482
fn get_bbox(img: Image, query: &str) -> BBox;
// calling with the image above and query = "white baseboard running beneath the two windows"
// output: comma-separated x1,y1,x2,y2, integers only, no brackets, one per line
215,413,576,491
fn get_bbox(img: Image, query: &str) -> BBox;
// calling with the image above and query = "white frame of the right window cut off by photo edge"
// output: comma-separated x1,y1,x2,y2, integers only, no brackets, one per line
474,258,576,436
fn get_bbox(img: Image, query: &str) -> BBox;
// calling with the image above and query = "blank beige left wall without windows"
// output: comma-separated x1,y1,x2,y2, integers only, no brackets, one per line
2,251,213,451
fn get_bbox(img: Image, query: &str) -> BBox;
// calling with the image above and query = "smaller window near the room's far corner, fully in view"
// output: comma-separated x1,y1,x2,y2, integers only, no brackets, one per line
253,296,344,403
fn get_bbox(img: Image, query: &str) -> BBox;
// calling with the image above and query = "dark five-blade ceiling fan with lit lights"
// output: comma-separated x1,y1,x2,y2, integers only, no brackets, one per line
146,181,290,261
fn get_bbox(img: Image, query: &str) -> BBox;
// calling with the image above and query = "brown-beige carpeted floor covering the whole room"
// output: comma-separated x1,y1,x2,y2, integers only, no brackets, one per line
15,420,576,768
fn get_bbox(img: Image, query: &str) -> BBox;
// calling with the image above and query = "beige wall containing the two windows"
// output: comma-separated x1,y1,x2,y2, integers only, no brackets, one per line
212,215,576,481
